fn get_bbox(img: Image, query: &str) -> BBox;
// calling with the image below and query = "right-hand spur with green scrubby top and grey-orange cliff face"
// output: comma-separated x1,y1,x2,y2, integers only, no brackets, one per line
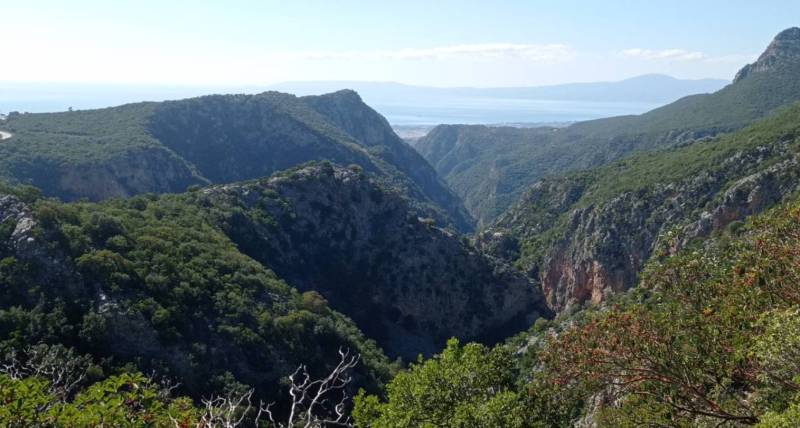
490,103,800,311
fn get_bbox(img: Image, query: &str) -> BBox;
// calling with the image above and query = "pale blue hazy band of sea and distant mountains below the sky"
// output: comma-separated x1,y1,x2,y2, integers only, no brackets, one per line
0,74,729,124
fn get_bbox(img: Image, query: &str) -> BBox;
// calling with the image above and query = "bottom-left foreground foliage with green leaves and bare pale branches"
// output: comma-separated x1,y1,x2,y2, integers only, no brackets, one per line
0,345,360,428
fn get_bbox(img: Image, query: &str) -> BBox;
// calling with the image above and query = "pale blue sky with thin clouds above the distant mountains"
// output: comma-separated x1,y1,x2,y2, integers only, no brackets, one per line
0,0,800,87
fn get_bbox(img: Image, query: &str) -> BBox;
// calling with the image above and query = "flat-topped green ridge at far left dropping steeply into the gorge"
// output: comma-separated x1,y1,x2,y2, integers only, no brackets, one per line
0,92,472,230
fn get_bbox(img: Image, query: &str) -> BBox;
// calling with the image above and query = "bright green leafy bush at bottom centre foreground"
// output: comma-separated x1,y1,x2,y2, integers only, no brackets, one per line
354,339,525,427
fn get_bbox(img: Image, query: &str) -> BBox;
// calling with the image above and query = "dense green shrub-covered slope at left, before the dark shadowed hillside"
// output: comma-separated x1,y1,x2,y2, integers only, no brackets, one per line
0,186,391,404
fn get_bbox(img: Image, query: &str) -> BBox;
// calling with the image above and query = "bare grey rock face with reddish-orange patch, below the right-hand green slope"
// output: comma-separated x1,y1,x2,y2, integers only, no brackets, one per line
541,147,800,310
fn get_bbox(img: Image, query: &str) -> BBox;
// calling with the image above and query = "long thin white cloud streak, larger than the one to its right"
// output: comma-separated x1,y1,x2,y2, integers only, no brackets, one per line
287,43,575,63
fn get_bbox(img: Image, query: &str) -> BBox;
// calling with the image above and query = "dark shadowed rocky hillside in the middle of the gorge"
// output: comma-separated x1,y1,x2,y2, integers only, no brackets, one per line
204,164,549,359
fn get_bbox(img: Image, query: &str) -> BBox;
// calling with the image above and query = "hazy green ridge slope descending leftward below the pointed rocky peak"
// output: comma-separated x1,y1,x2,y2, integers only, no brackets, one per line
414,27,800,225
